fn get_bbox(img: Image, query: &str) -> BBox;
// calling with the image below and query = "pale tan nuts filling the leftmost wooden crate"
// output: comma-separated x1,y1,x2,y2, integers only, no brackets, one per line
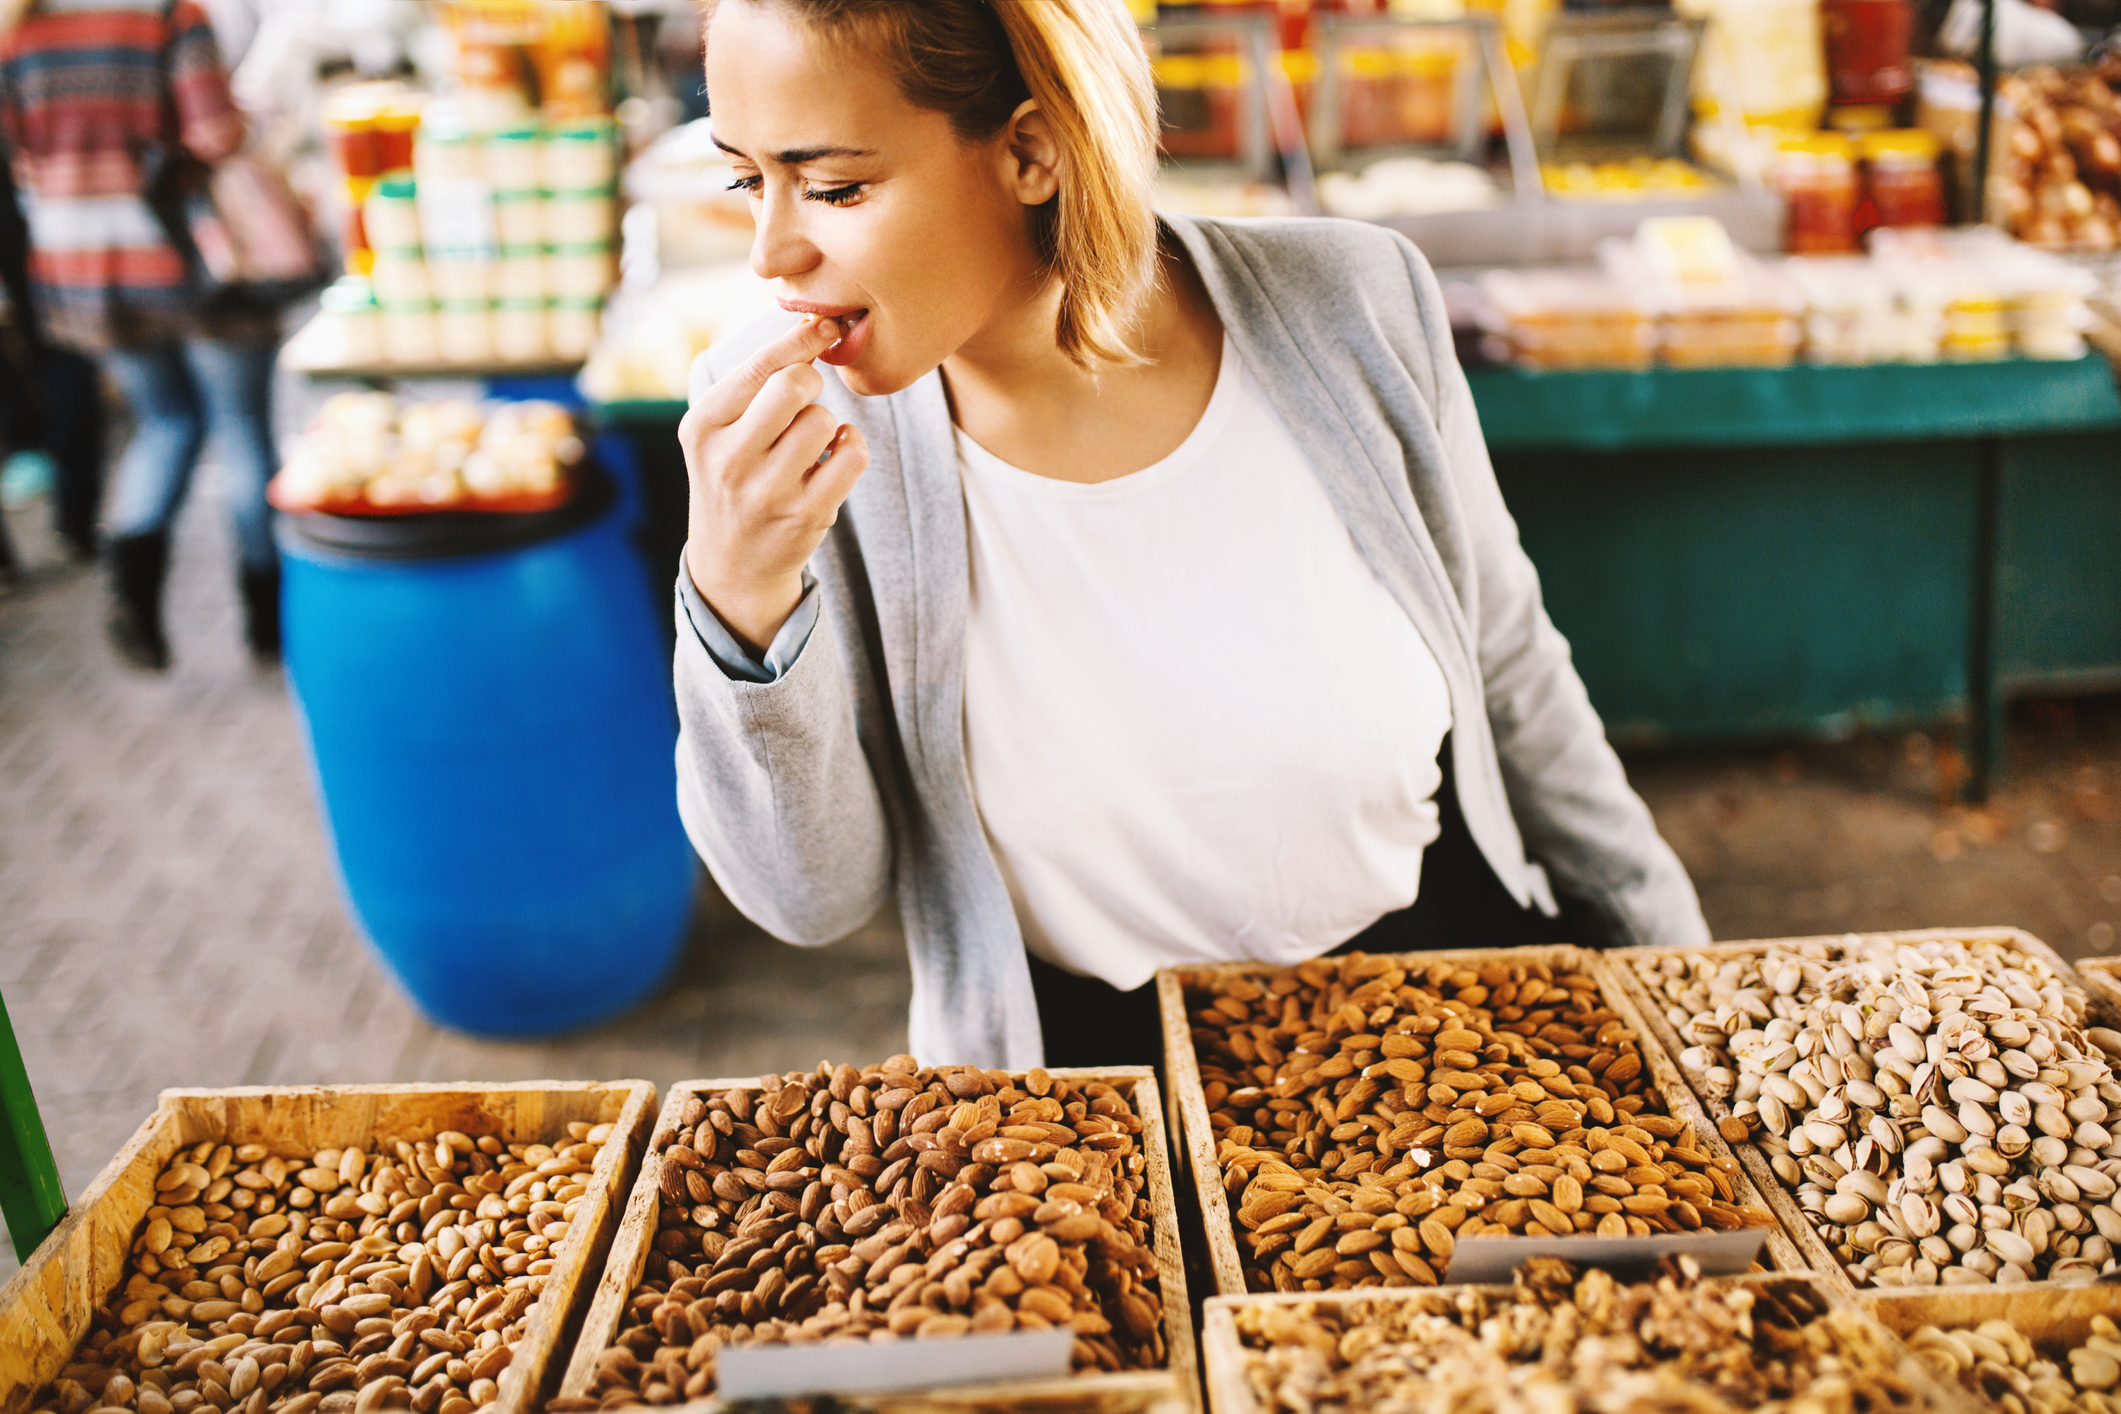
34,1121,611,1414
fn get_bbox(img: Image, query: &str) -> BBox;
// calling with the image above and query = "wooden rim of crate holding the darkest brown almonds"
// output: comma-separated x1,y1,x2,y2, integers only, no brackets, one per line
560,1066,1200,1414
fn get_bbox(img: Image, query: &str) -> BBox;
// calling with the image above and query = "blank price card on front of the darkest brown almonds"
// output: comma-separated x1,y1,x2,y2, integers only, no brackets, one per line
715,1327,1075,1399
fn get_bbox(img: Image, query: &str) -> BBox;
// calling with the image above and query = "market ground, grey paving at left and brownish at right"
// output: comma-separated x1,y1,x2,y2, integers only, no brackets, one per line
12,466,2121,1274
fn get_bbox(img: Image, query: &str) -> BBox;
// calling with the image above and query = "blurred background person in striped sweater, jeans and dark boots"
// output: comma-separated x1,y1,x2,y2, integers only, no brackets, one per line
0,0,280,670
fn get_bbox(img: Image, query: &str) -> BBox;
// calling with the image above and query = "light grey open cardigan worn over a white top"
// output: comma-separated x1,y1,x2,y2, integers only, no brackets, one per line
677,216,1710,1068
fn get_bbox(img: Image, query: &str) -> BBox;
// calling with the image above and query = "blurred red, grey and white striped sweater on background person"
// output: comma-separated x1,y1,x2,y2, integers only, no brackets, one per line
0,0,244,352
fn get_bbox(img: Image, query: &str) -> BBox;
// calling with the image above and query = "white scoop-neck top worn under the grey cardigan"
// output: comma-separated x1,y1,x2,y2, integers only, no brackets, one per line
957,339,1451,990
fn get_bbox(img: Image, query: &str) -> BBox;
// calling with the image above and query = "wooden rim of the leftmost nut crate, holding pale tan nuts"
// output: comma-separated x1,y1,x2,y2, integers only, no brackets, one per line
0,1081,655,1414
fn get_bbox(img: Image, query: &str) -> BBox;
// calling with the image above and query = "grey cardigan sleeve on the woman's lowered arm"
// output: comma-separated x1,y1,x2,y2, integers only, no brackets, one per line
1404,244,1710,948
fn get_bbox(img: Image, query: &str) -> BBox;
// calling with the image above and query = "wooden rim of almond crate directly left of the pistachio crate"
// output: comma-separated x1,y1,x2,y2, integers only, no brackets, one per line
1156,945,1805,1295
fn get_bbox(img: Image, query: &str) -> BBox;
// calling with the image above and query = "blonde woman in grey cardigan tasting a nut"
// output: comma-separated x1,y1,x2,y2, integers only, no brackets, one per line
677,0,1707,1068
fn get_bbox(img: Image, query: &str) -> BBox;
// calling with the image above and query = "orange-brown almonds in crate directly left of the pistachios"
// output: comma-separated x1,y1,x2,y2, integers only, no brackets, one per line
1184,952,1773,1291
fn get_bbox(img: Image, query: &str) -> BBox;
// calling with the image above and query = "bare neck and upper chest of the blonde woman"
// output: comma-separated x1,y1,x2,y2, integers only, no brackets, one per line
942,237,1222,481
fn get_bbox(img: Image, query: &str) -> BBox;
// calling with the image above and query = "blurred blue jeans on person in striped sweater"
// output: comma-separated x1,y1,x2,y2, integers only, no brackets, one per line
104,339,280,572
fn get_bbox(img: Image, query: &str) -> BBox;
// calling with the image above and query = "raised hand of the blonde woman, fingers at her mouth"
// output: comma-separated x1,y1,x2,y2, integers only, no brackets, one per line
677,318,870,651
